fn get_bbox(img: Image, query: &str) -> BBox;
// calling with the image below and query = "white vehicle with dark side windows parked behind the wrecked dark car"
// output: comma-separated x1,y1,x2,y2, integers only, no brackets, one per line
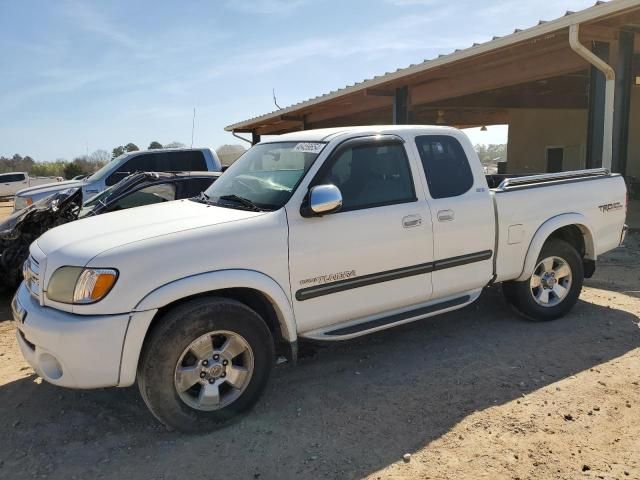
14,148,222,211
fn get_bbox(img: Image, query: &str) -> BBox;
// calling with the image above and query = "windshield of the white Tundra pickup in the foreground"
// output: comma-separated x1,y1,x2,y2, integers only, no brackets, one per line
204,142,325,210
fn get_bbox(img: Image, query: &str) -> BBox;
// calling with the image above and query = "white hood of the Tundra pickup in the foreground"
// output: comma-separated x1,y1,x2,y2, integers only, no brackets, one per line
37,200,264,265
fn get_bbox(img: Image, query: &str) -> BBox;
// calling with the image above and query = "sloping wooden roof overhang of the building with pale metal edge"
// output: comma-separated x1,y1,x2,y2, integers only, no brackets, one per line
225,0,640,134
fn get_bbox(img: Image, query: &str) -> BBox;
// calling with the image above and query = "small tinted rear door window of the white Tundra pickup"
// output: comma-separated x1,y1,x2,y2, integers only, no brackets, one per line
416,135,473,198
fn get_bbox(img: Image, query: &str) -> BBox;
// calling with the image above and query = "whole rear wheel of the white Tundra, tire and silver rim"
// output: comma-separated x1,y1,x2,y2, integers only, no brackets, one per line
502,239,584,321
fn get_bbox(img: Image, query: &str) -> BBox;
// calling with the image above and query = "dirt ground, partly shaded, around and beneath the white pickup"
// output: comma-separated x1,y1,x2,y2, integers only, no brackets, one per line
0,196,640,479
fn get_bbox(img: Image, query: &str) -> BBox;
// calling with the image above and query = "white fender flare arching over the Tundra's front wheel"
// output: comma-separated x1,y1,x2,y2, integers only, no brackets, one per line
118,270,298,387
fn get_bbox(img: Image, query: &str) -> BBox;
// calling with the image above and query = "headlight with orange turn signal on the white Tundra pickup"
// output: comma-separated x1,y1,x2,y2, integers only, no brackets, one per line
47,267,118,304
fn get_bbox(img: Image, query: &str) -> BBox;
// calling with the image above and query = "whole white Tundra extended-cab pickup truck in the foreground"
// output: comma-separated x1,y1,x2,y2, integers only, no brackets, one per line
12,126,626,431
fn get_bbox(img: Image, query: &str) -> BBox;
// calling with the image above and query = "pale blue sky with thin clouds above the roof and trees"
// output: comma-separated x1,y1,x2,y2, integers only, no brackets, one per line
0,0,594,161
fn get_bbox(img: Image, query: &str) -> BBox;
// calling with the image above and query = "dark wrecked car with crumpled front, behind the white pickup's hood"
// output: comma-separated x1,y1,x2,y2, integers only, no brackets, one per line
0,172,221,291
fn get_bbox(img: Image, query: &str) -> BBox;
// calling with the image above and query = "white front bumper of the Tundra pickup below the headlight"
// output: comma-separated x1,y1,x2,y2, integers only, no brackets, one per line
12,283,130,388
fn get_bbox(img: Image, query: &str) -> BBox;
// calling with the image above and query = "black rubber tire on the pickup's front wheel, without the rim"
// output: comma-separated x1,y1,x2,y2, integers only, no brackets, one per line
137,297,275,433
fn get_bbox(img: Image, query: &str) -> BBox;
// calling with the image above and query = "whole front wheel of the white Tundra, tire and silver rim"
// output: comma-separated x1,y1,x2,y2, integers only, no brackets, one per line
138,297,274,433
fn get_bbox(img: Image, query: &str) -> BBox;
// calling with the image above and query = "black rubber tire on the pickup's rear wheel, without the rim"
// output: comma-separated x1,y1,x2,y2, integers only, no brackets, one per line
502,239,584,322
